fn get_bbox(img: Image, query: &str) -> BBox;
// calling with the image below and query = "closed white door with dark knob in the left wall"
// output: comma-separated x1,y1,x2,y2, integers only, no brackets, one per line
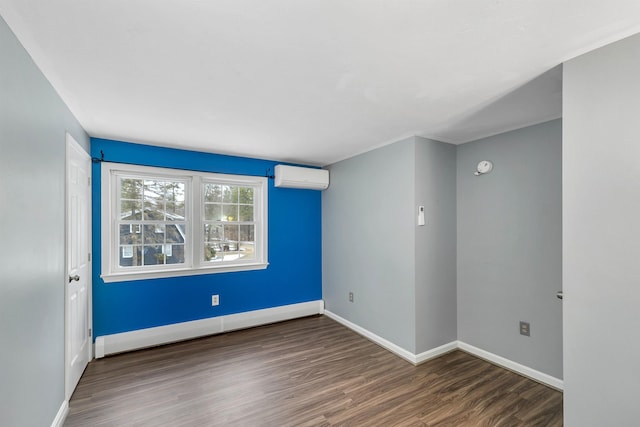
65,134,92,400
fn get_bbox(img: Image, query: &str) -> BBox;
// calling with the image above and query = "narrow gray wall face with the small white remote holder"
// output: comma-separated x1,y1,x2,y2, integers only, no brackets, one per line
414,137,457,354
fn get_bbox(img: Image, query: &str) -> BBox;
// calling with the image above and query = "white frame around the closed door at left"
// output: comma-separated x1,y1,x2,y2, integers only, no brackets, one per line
64,132,94,403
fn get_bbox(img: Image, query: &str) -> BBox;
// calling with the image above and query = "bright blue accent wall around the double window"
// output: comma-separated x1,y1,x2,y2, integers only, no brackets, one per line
91,138,322,337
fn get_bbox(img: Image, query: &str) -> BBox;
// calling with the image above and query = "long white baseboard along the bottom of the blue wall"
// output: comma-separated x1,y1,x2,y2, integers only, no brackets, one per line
95,300,324,359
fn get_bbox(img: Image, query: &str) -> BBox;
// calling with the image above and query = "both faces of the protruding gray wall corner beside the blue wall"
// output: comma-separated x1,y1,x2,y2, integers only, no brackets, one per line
322,137,457,354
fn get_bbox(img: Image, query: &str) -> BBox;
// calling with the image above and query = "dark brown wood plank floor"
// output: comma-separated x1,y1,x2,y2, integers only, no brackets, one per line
65,316,562,427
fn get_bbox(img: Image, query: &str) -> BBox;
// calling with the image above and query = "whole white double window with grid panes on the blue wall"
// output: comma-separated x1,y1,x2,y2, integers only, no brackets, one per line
102,163,267,282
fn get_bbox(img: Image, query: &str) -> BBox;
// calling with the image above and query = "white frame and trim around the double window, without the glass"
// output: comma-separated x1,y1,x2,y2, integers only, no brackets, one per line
100,162,269,283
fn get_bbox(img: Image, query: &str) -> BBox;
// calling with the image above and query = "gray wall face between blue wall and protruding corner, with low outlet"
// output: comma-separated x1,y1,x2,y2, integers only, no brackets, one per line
322,138,415,352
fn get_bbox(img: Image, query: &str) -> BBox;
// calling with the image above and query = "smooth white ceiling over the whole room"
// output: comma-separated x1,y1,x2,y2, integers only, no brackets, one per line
0,0,640,165
